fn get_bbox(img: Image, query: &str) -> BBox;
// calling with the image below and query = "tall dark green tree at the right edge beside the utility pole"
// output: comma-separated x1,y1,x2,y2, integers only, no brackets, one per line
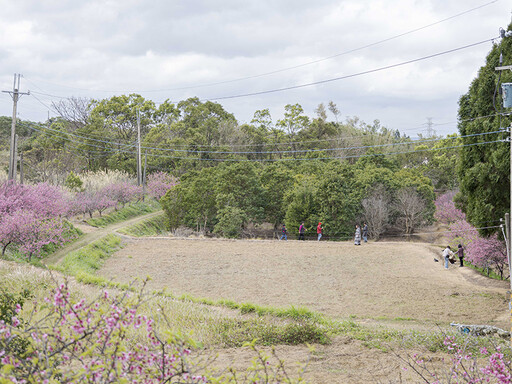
456,25,512,235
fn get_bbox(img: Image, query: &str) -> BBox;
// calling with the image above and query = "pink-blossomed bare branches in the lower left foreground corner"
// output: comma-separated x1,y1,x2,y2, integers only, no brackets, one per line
0,284,207,384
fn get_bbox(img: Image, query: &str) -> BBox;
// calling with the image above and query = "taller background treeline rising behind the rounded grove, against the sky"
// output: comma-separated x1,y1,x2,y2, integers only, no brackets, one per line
0,94,458,189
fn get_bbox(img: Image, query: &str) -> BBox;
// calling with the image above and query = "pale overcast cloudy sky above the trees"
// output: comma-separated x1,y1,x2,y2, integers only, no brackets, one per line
0,0,512,136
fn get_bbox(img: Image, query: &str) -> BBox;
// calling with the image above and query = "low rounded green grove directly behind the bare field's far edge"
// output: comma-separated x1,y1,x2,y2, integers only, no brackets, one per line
162,157,435,239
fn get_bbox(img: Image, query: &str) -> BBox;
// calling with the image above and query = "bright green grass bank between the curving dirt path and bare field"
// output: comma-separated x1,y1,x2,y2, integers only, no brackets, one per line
52,235,121,286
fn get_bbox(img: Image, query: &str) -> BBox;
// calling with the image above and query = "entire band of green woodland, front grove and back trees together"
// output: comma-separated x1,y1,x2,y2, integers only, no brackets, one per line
0,94,460,238
